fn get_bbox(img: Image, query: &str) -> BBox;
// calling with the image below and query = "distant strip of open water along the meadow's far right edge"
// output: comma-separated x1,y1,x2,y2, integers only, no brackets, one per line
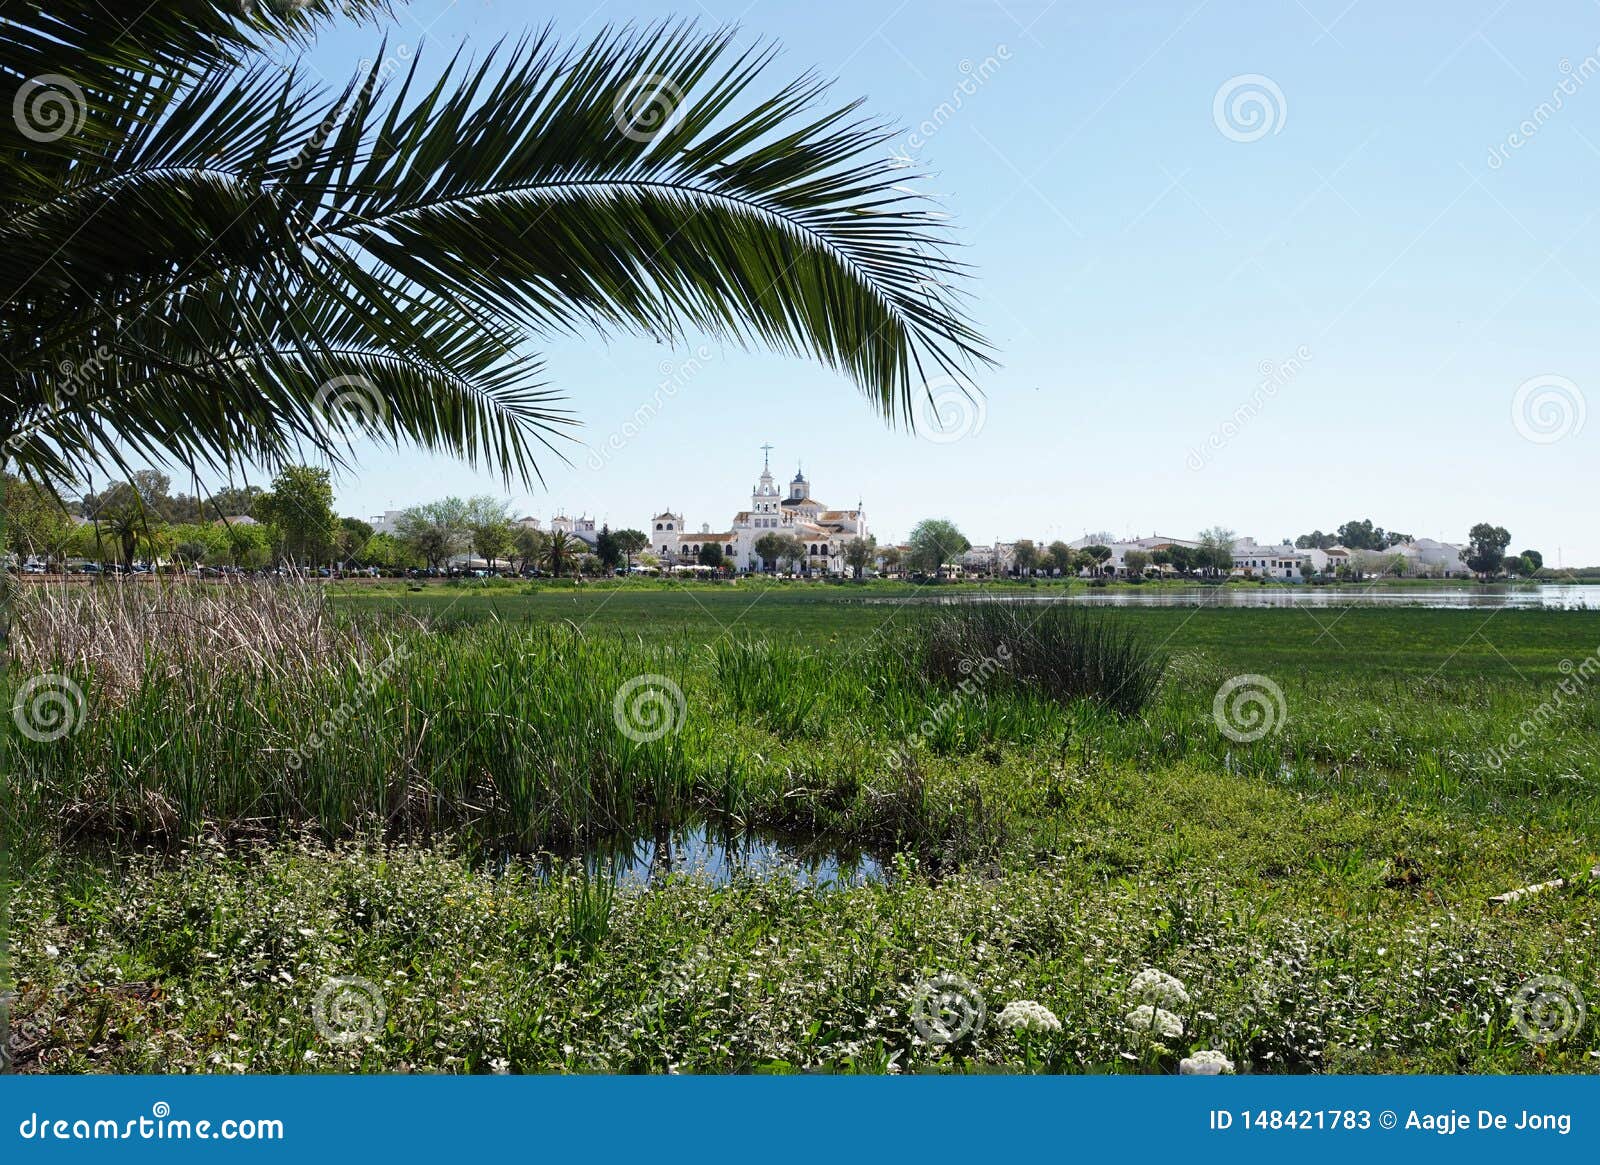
861,583,1600,611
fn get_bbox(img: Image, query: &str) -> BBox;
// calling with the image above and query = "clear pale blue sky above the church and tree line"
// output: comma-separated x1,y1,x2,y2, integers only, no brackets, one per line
275,0,1600,565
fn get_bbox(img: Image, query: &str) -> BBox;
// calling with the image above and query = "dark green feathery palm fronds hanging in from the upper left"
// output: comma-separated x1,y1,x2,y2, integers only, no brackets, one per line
0,0,989,488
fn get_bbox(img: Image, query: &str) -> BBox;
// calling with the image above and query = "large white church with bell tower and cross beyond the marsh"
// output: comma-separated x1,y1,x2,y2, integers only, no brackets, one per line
646,445,867,573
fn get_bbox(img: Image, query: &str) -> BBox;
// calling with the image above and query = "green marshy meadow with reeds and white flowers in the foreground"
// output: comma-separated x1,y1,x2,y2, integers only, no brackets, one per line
0,584,1600,1072
